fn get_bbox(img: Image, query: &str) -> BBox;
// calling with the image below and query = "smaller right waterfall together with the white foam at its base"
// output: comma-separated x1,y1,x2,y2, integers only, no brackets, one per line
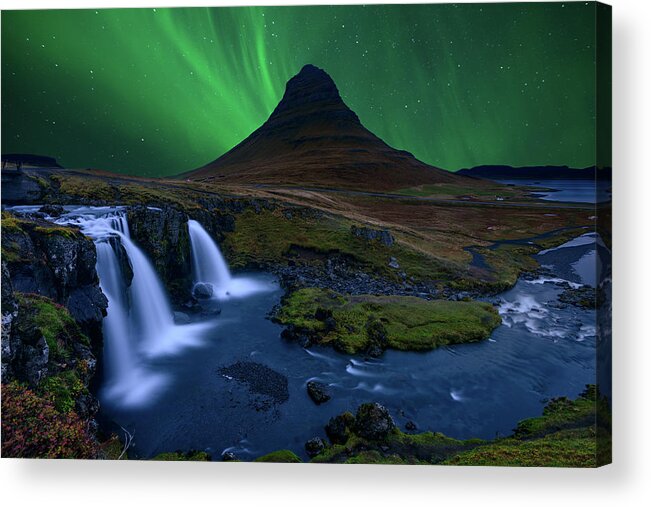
188,220,270,299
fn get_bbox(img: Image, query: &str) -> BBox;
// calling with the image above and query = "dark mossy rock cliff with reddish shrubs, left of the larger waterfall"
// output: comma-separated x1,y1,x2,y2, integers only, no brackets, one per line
2,214,107,458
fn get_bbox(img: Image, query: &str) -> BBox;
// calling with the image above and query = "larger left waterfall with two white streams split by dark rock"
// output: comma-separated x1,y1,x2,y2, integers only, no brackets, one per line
47,207,207,406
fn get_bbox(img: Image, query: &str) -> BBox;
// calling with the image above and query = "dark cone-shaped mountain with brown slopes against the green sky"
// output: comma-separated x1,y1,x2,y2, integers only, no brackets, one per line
182,65,477,191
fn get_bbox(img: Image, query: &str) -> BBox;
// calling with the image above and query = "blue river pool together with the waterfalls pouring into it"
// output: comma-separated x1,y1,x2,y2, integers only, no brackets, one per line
6,203,602,460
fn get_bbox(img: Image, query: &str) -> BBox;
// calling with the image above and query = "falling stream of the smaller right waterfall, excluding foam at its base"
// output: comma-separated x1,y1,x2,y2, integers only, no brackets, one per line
188,220,231,291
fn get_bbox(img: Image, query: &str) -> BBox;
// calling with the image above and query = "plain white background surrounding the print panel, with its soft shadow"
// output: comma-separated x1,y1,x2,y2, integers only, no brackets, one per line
0,0,651,507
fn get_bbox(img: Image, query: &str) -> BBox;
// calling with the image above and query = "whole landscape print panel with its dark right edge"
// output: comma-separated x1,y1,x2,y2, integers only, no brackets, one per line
2,2,612,467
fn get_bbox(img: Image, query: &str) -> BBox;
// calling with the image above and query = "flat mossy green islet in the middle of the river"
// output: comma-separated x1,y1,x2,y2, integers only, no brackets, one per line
275,288,501,354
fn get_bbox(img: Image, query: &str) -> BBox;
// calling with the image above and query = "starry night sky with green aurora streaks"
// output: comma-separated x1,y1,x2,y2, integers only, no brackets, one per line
2,2,595,176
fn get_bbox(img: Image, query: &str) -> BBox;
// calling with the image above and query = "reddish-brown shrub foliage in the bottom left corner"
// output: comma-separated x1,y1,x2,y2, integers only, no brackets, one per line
2,382,98,459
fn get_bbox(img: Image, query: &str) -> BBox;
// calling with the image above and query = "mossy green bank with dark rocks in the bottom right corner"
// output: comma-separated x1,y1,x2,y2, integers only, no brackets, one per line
312,385,611,467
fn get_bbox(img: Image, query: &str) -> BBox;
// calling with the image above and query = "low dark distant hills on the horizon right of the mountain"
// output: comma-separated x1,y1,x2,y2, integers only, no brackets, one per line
456,165,612,180
